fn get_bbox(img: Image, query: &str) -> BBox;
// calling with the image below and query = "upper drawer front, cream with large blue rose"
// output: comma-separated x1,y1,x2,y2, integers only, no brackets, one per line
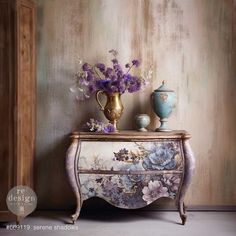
78,140,183,171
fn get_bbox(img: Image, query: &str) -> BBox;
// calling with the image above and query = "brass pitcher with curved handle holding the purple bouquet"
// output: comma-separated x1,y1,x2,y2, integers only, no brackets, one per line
96,90,124,132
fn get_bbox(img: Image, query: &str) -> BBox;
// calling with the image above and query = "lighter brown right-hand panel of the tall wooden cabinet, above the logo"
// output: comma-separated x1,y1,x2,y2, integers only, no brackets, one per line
17,0,36,187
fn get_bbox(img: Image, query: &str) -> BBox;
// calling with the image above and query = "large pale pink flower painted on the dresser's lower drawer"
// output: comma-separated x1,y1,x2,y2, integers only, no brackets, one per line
142,180,169,204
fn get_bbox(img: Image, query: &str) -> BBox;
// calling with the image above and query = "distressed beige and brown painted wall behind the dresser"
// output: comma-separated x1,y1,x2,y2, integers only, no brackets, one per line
36,0,236,208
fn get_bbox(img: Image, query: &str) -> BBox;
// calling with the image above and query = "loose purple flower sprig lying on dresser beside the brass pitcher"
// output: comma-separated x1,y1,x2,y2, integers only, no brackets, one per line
83,118,115,133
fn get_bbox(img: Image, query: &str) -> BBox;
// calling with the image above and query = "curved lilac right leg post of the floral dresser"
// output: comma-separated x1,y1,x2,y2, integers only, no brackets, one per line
177,137,195,225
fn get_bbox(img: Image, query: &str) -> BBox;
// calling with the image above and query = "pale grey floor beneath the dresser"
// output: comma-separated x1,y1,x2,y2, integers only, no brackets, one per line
0,210,236,236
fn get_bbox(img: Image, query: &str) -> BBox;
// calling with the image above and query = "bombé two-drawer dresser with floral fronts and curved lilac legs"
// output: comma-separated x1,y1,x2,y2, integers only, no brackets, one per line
66,131,194,224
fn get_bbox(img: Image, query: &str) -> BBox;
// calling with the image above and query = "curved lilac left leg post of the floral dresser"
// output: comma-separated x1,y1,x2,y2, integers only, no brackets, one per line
66,138,82,224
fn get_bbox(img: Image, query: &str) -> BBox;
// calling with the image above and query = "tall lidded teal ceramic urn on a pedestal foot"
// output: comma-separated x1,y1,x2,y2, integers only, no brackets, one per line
151,81,176,131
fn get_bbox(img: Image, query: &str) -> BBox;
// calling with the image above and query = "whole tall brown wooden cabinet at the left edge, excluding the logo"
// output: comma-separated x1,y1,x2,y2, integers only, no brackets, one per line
0,0,36,220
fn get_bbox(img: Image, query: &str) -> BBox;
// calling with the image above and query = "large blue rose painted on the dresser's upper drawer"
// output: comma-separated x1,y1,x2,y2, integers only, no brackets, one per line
142,145,176,170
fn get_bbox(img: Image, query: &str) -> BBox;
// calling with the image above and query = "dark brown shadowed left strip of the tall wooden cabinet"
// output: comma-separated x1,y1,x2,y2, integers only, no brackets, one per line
0,0,14,215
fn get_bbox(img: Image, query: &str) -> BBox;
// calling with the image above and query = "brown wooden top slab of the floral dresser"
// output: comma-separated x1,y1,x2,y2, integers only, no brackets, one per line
71,130,191,140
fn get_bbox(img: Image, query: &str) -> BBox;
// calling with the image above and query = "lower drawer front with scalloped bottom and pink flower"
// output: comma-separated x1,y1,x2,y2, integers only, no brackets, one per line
79,174,182,209
